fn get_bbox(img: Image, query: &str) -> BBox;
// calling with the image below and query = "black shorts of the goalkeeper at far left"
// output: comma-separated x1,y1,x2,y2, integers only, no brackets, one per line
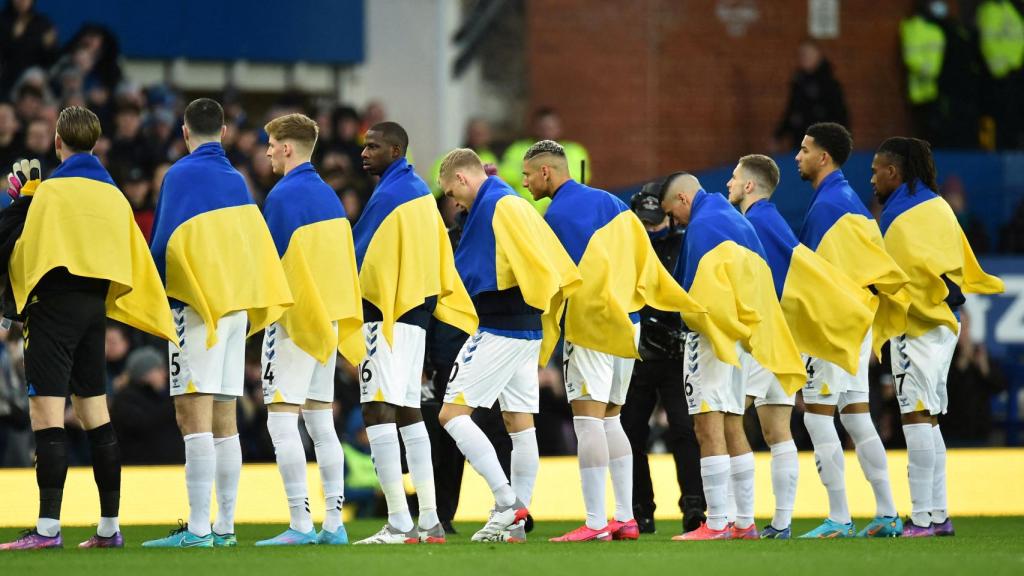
25,291,106,398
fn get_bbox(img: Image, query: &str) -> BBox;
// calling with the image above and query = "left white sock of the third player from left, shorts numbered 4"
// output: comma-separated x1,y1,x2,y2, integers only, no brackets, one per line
266,412,313,534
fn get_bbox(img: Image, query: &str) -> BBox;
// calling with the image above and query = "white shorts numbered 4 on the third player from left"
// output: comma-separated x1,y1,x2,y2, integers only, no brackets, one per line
261,322,338,405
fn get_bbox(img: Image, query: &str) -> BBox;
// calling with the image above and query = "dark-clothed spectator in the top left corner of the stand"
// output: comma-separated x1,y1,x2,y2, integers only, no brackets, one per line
0,0,57,96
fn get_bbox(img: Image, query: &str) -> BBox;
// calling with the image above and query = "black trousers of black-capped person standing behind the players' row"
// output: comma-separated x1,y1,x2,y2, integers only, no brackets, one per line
622,360,703,519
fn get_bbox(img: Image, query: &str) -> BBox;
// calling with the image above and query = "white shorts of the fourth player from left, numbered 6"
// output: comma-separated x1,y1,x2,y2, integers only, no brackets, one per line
359,322,427,408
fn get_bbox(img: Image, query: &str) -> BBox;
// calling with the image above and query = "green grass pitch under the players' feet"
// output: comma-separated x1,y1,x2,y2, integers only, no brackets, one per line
0,517,1024,576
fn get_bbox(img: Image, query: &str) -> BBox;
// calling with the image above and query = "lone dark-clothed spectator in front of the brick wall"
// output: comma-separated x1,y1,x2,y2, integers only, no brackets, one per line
774,40,850,150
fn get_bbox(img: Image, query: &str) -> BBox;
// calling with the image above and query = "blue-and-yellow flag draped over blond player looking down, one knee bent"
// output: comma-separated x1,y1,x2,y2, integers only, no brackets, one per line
455,176,583,365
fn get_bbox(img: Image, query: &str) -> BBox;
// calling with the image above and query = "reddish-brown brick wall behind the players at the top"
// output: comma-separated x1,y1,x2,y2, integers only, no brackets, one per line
526,0,911,188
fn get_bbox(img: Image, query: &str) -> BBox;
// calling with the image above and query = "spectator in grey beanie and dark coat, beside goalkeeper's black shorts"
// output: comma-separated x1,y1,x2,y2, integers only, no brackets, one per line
111,346,185,464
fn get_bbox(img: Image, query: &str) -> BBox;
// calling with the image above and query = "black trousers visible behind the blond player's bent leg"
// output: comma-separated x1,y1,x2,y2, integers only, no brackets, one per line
420,366,512,523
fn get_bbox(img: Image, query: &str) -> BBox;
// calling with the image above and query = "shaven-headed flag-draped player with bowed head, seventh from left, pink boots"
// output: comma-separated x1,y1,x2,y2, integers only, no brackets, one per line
662,172,805,540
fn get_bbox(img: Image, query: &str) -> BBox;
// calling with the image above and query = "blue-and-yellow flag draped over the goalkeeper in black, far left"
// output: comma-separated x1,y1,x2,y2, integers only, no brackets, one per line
9,154,177,342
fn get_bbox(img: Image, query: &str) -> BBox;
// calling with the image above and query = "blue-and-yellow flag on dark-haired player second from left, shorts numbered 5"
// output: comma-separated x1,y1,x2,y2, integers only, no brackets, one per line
151,142,293,347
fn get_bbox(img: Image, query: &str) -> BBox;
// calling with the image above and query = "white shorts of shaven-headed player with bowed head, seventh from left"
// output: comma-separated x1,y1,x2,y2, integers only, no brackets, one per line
683,332,746,415
